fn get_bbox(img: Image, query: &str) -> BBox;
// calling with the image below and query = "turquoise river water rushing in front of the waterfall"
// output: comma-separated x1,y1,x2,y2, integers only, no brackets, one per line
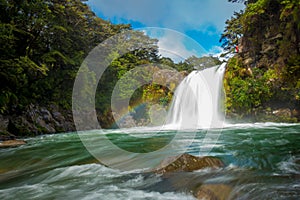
0,123,300,200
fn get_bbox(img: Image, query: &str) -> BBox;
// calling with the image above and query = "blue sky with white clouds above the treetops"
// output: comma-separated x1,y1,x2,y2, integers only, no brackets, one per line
88,0,244,61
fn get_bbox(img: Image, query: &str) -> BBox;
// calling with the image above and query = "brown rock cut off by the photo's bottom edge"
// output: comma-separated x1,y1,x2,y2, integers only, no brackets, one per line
195,184,232,200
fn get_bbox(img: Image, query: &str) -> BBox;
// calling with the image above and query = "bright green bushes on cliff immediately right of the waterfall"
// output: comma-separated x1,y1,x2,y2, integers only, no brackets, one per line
225,58,276,116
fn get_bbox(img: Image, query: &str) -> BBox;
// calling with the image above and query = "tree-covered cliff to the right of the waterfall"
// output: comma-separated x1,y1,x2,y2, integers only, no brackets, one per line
221,0,300,121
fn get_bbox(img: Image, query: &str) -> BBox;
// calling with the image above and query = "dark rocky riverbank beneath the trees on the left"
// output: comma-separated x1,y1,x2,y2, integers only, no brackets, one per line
0,104,75,141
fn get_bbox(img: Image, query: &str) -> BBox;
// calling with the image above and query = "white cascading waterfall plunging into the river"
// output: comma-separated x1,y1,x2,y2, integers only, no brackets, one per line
166,63,225,129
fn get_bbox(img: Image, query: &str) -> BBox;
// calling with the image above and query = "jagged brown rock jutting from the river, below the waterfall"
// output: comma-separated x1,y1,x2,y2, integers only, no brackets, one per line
155,153,224,174
